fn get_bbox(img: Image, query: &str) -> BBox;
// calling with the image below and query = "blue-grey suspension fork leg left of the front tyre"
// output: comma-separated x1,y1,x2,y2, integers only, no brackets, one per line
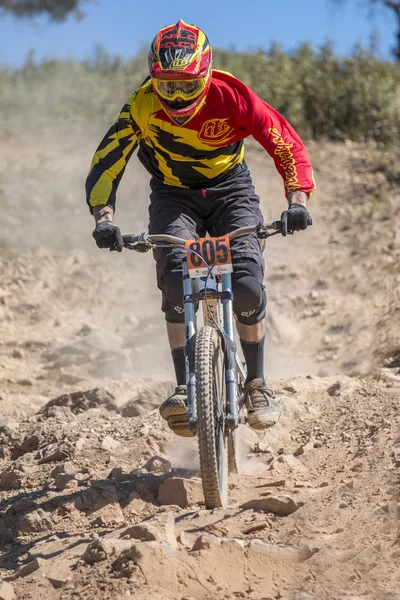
182,258,197,434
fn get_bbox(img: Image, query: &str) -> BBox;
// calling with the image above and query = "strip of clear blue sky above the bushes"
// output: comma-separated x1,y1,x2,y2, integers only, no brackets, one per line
0,0,395,67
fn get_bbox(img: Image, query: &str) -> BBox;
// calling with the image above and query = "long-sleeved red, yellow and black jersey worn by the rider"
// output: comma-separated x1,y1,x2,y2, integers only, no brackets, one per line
86,70,315,208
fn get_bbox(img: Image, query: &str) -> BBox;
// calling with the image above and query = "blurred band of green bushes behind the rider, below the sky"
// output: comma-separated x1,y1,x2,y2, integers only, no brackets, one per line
0,44,400,146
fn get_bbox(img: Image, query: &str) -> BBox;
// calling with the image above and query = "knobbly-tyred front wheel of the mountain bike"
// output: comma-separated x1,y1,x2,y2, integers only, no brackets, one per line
195,325,228,508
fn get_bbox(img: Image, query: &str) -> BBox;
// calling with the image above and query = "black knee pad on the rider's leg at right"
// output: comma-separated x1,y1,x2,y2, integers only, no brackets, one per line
232,260,267,325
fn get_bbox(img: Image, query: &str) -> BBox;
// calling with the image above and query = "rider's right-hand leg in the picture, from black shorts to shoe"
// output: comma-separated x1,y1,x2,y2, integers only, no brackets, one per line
205,169,279,429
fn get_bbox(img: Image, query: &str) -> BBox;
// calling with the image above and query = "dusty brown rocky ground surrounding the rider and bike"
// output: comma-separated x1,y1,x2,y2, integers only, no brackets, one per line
0,136,400,600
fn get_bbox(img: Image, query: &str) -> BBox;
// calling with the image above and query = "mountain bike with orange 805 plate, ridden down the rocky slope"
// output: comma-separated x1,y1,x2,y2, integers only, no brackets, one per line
115,221,281,509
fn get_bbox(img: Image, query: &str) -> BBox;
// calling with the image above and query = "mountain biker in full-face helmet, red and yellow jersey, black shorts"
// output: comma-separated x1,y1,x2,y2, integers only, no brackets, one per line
86,20,315,436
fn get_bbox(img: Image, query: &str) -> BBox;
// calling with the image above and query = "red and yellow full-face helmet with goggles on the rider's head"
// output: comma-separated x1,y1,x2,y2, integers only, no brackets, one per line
149,20,211,124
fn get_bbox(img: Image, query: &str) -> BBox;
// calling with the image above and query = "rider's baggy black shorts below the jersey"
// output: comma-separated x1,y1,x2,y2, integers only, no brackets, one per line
149,164,264,320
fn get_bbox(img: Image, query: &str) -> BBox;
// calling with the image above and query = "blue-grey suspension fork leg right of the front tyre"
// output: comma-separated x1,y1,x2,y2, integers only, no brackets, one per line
222,273,239,429
